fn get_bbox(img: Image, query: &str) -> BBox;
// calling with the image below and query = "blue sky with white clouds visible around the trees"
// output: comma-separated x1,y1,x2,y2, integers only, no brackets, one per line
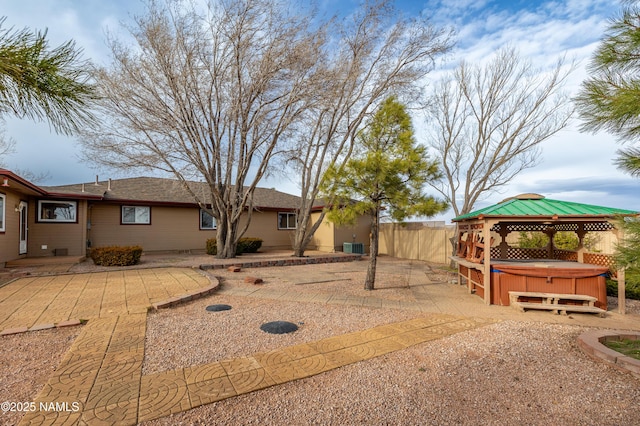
0,0,640,221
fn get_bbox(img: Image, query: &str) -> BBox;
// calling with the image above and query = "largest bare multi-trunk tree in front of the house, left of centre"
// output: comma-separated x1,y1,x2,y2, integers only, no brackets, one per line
77,0,323,257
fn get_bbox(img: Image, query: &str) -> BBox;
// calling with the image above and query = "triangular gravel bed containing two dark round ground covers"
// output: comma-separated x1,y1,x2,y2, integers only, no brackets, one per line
142,296,428,374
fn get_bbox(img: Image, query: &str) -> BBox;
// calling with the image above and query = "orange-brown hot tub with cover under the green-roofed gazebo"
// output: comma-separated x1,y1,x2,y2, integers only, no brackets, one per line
482,259,608,310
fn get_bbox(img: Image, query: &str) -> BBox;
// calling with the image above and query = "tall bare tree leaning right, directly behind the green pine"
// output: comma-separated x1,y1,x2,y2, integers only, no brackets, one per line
289,0,452,256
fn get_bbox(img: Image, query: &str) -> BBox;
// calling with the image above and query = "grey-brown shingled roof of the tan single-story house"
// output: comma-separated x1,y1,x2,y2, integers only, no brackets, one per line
42,177,300,209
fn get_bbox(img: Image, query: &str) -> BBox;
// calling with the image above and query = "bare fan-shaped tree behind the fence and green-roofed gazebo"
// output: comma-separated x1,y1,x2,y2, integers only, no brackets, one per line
427,48,573,216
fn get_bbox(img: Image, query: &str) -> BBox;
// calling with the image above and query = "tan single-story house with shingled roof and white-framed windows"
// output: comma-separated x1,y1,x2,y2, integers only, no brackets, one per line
0,169,369,266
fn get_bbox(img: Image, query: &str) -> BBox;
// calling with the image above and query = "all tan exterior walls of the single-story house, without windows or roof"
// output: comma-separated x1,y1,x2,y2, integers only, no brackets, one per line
0,197,370,263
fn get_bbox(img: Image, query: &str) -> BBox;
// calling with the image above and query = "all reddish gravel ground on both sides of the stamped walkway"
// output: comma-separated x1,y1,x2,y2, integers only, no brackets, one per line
143,268,640,426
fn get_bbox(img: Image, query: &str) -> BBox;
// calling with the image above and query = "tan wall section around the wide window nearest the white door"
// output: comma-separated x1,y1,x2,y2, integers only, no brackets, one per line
27,199,87,257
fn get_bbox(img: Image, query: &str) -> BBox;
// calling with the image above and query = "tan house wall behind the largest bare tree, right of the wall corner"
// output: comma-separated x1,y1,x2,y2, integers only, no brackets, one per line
89,204,298,251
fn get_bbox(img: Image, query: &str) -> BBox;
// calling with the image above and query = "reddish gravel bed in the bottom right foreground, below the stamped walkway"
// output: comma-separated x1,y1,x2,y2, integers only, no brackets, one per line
145,321,640,426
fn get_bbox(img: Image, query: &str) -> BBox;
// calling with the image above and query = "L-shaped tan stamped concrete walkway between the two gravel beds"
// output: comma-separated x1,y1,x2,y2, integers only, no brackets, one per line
20,314,495,425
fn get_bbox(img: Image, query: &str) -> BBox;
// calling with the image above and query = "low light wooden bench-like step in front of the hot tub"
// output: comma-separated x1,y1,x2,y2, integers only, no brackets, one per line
509,291,606,317
